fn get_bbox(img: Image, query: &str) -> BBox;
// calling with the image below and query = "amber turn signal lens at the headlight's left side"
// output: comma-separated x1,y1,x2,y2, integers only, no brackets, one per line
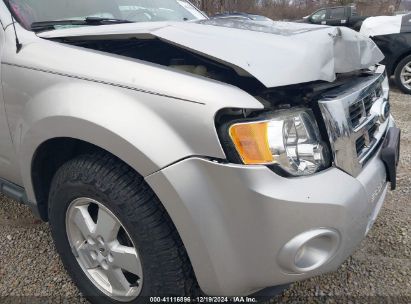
229,122,274,165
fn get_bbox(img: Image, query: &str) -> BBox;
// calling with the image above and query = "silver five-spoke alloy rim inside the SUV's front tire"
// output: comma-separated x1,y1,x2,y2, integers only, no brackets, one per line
66,197,143,301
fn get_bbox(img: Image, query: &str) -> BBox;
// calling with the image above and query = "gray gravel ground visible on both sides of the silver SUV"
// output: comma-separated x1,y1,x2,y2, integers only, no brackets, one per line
0,92,411,303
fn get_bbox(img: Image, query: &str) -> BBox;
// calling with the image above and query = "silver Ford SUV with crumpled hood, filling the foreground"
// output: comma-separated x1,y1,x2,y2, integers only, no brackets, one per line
0,0,400,303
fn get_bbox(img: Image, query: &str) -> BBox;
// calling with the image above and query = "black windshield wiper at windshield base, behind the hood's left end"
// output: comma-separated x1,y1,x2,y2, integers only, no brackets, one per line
31,17,134,32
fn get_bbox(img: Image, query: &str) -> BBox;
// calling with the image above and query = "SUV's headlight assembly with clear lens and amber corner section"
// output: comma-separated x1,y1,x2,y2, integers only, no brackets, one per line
229,108,330,176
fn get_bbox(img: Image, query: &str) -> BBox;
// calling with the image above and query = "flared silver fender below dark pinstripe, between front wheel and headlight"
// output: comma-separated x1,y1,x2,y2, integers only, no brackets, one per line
12,80,225,201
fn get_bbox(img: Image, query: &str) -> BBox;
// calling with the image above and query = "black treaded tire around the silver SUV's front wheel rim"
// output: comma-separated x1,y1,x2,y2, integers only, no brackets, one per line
49,153,199,303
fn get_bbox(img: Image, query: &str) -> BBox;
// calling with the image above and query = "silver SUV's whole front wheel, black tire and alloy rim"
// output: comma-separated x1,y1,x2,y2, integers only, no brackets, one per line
49,154,198,303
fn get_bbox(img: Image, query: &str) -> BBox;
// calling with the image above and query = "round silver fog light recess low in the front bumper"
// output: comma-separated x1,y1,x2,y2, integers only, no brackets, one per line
278,228,340,273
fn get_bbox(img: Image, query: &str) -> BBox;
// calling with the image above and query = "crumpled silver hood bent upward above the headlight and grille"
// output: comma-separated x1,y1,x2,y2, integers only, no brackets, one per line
38,19,384,88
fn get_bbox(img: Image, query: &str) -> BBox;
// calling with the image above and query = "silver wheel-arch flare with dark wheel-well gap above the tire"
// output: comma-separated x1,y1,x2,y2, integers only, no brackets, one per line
18,117,161,219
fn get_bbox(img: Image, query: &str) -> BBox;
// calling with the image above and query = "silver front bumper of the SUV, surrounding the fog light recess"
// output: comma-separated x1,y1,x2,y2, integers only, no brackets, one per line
146,119,393,296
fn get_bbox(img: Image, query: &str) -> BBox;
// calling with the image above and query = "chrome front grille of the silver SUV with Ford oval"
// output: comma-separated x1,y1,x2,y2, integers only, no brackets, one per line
319,67,389,176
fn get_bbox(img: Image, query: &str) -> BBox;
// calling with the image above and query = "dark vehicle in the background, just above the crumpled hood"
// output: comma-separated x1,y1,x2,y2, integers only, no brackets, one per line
302,6,367,31
